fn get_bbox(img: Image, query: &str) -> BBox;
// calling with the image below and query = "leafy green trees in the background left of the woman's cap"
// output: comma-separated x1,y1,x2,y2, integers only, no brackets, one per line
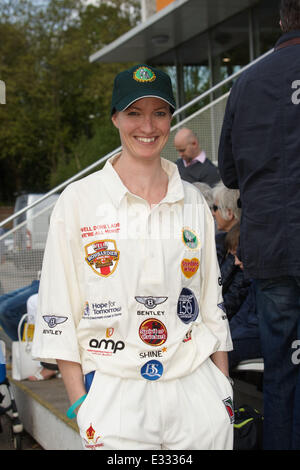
0,0,139,201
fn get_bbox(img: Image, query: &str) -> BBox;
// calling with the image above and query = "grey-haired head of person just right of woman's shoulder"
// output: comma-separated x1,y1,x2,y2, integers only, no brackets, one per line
212,182,241,232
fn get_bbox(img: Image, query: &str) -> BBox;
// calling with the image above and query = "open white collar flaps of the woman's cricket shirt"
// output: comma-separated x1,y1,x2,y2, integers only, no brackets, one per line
101,154,184,207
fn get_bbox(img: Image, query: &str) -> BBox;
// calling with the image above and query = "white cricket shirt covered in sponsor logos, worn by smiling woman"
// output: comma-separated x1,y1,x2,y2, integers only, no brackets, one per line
33,157,232,380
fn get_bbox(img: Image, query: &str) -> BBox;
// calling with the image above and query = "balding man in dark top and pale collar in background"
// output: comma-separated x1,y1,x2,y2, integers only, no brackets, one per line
174,127,220,187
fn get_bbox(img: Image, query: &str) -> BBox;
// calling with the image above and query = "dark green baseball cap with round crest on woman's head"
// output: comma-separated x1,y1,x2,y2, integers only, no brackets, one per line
111,65,176,115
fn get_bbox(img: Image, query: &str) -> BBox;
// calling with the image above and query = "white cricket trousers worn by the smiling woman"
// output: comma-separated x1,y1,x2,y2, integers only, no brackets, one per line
77,359,233,450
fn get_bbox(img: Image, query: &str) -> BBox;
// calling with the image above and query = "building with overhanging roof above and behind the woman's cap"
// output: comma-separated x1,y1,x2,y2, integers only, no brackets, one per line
91,0,280,105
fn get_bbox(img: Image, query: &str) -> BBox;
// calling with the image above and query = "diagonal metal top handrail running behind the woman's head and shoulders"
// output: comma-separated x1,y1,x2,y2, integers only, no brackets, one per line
0,49,274,227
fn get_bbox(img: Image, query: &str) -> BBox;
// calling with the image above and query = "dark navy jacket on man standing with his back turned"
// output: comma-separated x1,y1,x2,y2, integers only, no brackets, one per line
219,31,300,278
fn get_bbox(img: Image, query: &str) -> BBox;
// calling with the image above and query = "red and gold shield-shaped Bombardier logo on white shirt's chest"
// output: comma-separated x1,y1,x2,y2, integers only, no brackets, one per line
84,240,120,277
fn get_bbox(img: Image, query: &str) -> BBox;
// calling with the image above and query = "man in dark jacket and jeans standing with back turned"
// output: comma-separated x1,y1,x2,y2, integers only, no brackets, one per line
219,0,300,450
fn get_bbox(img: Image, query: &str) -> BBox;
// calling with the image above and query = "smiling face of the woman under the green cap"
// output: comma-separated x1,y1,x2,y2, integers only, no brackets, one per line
112,97,172,159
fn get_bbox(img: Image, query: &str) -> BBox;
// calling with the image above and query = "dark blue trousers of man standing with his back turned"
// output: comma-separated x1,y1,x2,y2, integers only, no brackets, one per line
255,276,300,450
